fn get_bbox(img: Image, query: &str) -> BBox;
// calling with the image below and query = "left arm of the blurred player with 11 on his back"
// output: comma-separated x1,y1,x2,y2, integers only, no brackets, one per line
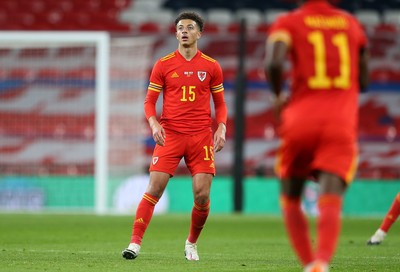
264,31,291,117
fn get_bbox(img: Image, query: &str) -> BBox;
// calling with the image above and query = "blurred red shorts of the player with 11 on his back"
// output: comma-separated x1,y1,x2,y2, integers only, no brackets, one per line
275,124,358,183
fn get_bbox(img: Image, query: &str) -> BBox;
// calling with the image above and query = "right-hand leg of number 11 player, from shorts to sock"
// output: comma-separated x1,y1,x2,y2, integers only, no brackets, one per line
306,124,358,269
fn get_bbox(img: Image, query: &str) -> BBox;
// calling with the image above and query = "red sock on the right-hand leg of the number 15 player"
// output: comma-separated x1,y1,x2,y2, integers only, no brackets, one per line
188,201,210,243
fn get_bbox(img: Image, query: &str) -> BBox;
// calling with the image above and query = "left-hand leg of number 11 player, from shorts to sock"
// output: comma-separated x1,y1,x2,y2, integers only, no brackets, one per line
275,126,319,266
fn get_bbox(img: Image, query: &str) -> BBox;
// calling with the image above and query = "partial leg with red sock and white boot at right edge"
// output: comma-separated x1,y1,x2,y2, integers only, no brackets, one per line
367,193,400,245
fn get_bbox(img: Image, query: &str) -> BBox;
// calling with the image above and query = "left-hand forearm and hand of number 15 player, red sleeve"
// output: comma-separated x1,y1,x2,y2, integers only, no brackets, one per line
144,83,166,146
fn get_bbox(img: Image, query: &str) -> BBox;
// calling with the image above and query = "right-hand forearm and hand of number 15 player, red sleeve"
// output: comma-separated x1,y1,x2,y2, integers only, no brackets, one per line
212,90,228,152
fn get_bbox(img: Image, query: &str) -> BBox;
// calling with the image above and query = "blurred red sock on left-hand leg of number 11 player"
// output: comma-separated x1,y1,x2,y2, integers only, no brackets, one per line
281,195,314,265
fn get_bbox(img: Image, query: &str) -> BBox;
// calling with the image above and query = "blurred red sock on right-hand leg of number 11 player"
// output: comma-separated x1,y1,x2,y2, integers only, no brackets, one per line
315,194,342,263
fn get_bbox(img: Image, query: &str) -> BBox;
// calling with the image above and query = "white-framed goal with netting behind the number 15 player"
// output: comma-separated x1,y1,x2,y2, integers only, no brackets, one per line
0,32,153,213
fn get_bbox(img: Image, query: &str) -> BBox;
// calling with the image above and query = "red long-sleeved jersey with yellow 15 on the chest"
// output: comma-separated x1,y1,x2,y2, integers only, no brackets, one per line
145,50,226,134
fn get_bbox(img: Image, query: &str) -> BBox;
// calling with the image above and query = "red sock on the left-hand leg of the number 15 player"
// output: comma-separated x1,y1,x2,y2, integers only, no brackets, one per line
131,193,158,245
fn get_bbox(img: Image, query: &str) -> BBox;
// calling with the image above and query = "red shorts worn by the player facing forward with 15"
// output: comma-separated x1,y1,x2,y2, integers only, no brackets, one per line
149,130,215,176
